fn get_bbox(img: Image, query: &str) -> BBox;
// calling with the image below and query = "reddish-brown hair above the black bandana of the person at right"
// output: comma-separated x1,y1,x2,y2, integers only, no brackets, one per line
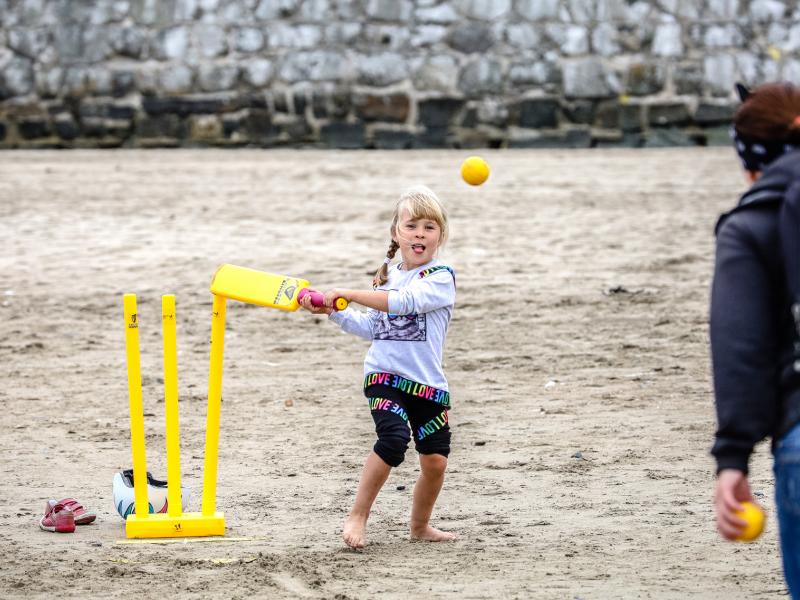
733,83,800,145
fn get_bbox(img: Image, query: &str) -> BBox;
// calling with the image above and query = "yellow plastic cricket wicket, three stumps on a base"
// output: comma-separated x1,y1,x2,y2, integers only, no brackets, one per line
123,294,225,538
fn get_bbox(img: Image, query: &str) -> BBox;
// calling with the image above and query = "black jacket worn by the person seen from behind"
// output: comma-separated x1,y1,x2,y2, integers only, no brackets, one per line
710,152,800,473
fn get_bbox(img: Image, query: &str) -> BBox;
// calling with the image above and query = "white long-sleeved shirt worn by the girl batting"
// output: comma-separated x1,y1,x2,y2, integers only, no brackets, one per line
329,260,456,391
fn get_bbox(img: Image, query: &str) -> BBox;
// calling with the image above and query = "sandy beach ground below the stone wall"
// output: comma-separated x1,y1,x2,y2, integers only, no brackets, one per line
0,149,785,599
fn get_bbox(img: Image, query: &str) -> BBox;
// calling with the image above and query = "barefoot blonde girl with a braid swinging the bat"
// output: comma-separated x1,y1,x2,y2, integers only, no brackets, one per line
302,186,456,548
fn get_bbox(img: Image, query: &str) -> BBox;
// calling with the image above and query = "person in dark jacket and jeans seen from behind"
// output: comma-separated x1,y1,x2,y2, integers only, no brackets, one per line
710,84,800,599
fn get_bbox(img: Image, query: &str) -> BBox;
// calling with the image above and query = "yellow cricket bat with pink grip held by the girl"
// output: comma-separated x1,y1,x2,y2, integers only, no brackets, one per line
211,264,348,310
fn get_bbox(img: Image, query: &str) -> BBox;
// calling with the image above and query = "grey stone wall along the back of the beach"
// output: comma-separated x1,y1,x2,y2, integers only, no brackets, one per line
0,0,800,148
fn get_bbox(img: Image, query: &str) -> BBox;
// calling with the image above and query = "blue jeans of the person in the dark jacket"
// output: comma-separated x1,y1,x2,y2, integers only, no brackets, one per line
774,424,800,600
